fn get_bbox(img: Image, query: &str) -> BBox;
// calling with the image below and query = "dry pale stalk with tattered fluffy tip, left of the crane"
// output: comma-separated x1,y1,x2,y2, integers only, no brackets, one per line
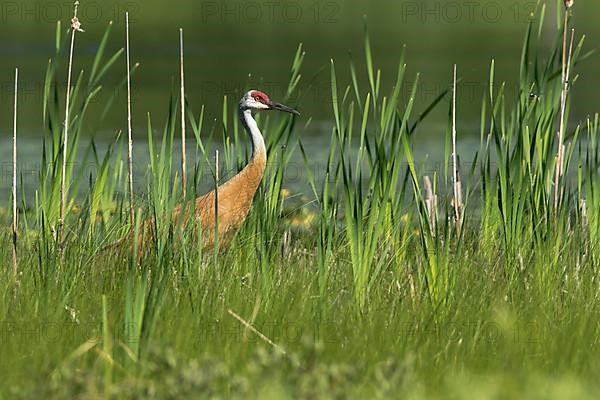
57,1,83,250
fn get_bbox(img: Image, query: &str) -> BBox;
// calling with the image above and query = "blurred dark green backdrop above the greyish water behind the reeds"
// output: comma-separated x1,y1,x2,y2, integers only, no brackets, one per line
0,0,600,136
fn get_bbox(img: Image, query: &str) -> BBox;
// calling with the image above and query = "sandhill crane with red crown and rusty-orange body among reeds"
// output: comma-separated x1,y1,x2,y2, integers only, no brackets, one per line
162,90,300,248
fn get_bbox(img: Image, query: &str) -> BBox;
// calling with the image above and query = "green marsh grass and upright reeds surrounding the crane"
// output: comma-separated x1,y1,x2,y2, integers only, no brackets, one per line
0,1,600,399
